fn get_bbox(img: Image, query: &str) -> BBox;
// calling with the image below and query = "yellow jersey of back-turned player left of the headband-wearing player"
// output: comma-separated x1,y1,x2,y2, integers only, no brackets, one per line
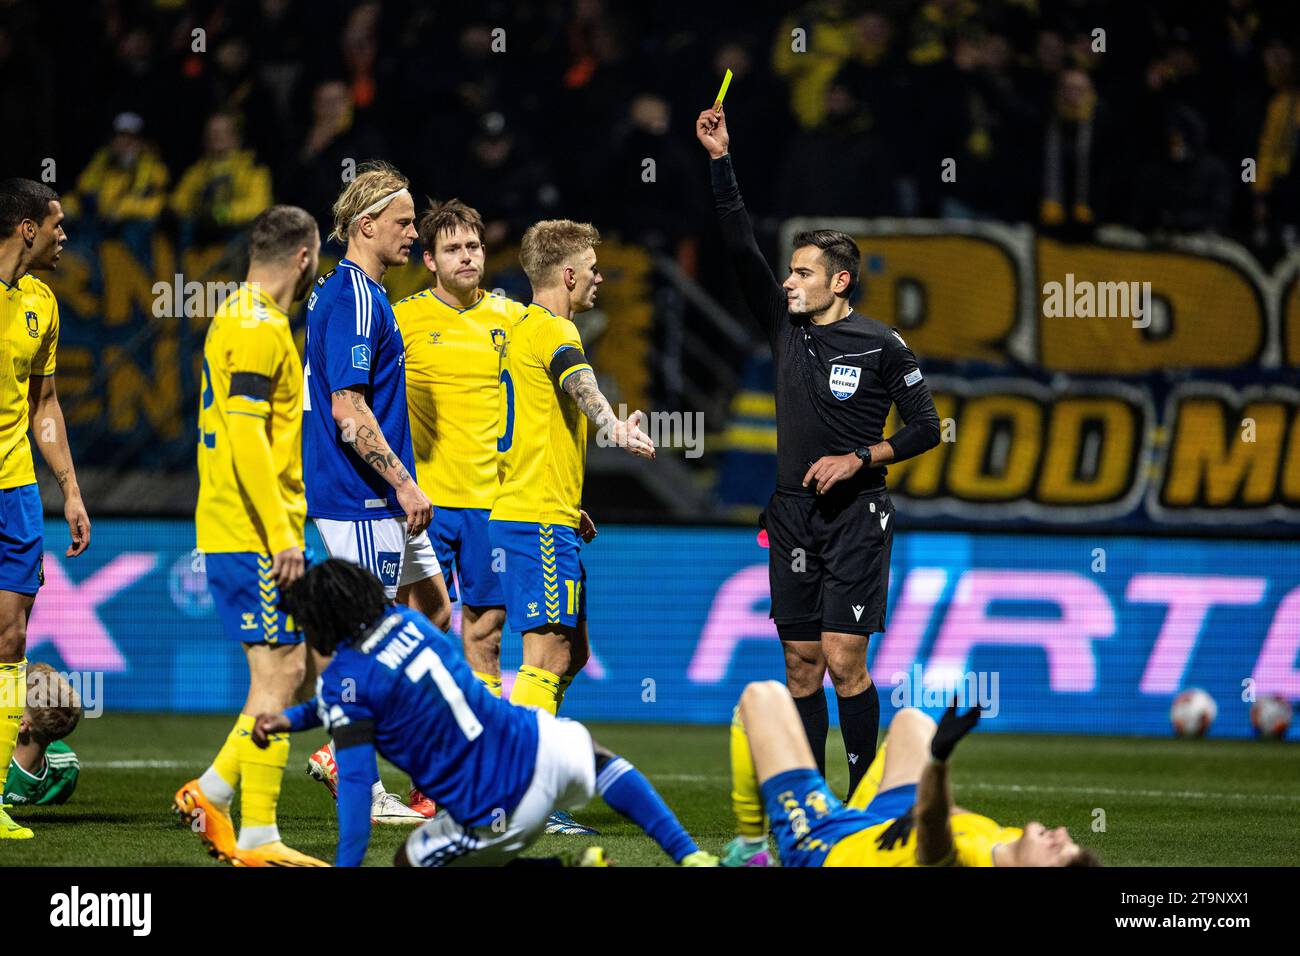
195,285,307,554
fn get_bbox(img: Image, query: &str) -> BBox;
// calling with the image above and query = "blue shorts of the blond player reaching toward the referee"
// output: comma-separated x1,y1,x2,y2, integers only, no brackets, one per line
488,522,586,633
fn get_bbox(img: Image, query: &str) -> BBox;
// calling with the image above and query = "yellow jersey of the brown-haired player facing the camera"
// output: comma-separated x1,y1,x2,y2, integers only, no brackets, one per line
393,289,528,509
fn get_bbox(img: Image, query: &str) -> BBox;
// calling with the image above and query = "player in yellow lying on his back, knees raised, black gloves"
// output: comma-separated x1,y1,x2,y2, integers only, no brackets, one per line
723,680,1099,866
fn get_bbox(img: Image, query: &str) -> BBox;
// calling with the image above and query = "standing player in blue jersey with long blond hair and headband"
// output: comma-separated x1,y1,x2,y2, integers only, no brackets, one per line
303,161,450,823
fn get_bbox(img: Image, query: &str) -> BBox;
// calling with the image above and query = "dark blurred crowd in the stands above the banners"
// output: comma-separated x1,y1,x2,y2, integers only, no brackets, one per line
0,0,1300,261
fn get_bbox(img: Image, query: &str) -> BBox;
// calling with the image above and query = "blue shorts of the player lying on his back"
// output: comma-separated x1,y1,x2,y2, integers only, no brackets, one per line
762,769,917,866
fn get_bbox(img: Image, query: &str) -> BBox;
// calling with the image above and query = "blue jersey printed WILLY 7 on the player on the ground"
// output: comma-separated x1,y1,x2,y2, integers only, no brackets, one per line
316,605,537,826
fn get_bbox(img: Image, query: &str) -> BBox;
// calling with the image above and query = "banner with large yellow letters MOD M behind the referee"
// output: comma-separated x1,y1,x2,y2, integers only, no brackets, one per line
718,219,1300,535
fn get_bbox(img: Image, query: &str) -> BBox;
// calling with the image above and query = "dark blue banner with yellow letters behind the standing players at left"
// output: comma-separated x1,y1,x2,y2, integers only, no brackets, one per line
40,232,654,470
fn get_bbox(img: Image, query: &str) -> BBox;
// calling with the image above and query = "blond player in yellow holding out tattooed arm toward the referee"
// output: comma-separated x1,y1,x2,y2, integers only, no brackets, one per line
488,220,655,834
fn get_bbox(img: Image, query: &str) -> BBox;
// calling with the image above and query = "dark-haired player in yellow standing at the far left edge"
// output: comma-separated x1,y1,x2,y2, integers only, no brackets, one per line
0,178,90,840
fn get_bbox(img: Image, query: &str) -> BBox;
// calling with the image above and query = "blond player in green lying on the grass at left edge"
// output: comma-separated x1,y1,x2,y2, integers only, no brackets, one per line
4,663,82,806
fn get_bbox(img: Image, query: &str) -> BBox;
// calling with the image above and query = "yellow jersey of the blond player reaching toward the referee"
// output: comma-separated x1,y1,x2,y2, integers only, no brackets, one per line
491,303,592,528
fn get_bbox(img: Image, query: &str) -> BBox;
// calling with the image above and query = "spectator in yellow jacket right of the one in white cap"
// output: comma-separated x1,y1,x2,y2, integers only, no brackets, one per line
170,113,270,239
